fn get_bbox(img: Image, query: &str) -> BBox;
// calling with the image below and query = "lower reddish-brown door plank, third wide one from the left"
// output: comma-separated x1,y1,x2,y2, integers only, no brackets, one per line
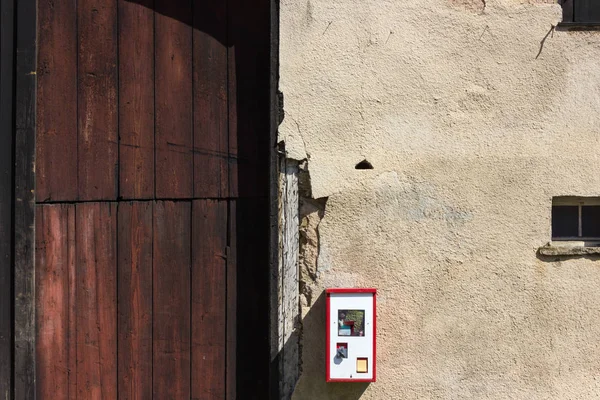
117,202,153,400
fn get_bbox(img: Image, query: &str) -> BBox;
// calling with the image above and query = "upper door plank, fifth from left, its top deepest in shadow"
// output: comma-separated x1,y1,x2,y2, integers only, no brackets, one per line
193,0,229,198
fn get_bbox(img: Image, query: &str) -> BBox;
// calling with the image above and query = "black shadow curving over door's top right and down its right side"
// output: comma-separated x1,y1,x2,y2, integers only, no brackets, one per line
126,0,271,400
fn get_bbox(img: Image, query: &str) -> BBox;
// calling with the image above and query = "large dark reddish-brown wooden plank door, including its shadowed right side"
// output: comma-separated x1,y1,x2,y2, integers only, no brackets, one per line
35,0,269,400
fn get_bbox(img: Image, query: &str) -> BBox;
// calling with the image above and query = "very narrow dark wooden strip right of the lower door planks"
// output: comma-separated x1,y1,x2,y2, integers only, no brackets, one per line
225,200,237,400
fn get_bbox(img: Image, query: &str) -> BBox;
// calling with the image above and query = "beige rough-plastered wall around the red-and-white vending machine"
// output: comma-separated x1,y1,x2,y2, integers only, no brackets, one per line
280,0,600,400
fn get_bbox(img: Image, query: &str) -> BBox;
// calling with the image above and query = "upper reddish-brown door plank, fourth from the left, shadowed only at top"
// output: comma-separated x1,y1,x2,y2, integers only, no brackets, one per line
155,0,193,198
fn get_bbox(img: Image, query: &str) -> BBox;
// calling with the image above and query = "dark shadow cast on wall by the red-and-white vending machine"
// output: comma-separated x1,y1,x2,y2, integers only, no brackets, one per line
292,291,369,400
